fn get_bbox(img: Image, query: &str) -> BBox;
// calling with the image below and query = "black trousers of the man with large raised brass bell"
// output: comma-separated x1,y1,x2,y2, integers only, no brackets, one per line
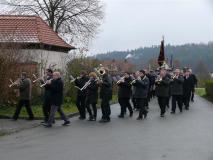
101,98,111,120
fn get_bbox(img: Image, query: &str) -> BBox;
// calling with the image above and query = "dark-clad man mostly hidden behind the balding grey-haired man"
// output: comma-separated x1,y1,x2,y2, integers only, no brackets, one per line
40,69,53,123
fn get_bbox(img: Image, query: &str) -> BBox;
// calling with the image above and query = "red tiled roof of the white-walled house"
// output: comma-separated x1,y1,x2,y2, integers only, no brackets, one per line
0,15,74,49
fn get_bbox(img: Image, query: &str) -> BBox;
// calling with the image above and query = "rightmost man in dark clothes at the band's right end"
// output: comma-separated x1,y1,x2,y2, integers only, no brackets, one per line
183,69,194,110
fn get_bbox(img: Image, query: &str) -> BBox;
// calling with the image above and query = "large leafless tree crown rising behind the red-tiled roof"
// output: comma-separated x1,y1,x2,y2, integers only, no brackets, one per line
4,0,104,45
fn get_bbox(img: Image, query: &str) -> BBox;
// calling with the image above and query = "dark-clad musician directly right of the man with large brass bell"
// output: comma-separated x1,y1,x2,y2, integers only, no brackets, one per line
117,72,133,118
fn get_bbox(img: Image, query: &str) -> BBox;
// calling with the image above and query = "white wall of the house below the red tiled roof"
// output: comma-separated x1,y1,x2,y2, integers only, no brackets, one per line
21,49,68,71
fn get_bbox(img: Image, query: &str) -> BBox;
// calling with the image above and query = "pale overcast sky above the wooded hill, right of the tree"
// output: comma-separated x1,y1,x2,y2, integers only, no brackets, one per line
90,0,213,54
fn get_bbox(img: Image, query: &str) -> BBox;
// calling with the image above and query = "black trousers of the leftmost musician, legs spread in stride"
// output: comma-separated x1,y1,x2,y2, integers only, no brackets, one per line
13,100,34,120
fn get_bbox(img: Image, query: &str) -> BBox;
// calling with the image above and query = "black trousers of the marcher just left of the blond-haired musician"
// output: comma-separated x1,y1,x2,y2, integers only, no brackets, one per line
76,96,86,118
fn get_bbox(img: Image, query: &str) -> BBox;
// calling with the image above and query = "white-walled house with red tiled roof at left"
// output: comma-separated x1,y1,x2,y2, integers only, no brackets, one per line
0,15,75,71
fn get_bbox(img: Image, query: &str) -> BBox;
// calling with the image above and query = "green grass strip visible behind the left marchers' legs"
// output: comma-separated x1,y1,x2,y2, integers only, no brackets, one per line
0,95,117,118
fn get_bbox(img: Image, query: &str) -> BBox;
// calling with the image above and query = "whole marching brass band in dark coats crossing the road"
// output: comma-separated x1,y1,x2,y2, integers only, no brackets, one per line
9,67,197,127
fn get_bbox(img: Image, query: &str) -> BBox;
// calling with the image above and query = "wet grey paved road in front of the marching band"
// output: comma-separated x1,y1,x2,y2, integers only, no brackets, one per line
0,97,213,160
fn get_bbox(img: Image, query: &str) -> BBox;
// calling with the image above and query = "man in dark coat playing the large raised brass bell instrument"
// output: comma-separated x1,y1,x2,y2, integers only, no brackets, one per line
99,69,112,123
